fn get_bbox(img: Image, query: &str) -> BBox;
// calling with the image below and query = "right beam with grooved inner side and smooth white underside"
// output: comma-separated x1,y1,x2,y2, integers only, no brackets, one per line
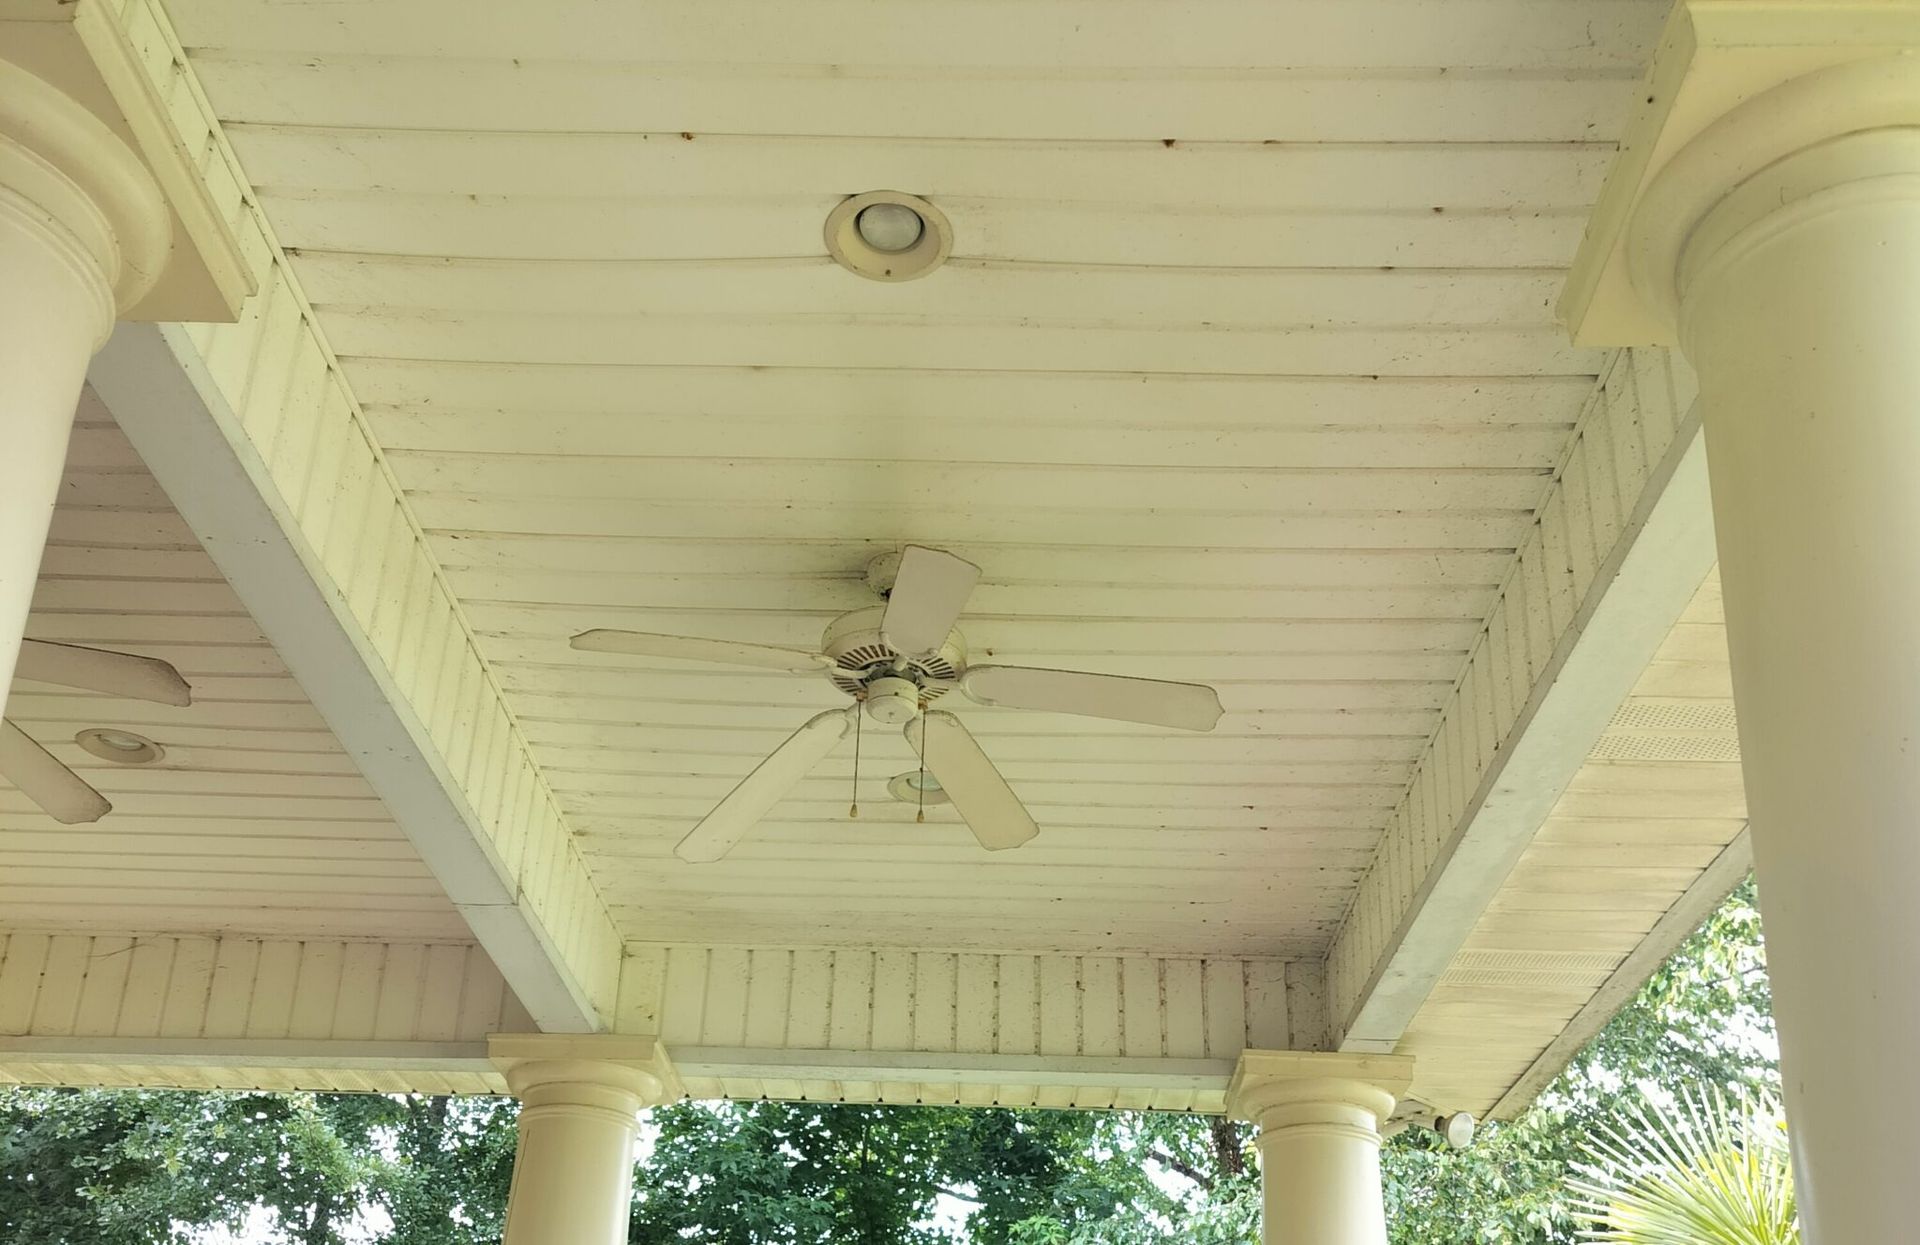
1329,352,1715,1053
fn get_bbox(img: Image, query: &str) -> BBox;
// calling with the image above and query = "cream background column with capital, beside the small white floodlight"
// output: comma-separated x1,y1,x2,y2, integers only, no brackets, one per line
1227,1051,1411,1245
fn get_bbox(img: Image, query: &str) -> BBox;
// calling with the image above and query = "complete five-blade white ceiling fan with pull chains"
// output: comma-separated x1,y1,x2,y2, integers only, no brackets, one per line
572,546,1221,863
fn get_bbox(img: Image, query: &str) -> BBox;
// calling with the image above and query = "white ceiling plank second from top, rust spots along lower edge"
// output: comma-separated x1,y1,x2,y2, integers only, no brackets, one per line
190,46,1632,142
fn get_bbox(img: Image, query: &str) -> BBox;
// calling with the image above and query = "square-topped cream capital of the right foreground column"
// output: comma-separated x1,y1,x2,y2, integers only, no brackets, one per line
1559,0,1920,346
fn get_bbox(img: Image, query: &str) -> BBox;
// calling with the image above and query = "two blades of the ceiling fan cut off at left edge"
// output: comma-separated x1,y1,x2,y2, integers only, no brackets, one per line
0,640,194,826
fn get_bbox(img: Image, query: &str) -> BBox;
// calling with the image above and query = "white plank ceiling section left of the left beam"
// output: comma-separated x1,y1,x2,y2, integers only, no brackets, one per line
0,392,470,941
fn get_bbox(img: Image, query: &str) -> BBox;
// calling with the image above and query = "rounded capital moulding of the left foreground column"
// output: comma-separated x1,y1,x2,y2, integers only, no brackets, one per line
0,60,173,346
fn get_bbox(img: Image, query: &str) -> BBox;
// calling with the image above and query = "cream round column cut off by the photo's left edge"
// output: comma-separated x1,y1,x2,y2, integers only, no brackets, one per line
0,61,169,711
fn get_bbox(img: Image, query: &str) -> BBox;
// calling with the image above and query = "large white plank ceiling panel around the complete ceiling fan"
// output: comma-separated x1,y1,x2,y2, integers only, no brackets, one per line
173,0,1665,955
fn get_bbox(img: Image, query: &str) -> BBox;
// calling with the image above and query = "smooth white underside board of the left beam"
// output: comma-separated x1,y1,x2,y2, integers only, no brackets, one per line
88,325,611,1032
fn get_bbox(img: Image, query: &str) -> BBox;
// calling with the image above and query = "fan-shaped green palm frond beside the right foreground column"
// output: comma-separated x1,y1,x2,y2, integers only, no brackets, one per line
1571,1091,1799,1245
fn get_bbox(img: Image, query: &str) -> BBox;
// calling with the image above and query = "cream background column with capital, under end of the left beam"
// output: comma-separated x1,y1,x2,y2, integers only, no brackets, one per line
490,1036,672,1245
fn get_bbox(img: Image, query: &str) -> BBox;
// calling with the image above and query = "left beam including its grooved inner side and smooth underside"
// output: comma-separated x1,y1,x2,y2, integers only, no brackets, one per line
90,322,618,1032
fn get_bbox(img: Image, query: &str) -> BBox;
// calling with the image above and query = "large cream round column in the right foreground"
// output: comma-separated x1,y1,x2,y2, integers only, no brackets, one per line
1574,41,1920,1245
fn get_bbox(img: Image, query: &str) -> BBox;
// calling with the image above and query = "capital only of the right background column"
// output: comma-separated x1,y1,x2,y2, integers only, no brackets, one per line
1227,1051,1413,1135
